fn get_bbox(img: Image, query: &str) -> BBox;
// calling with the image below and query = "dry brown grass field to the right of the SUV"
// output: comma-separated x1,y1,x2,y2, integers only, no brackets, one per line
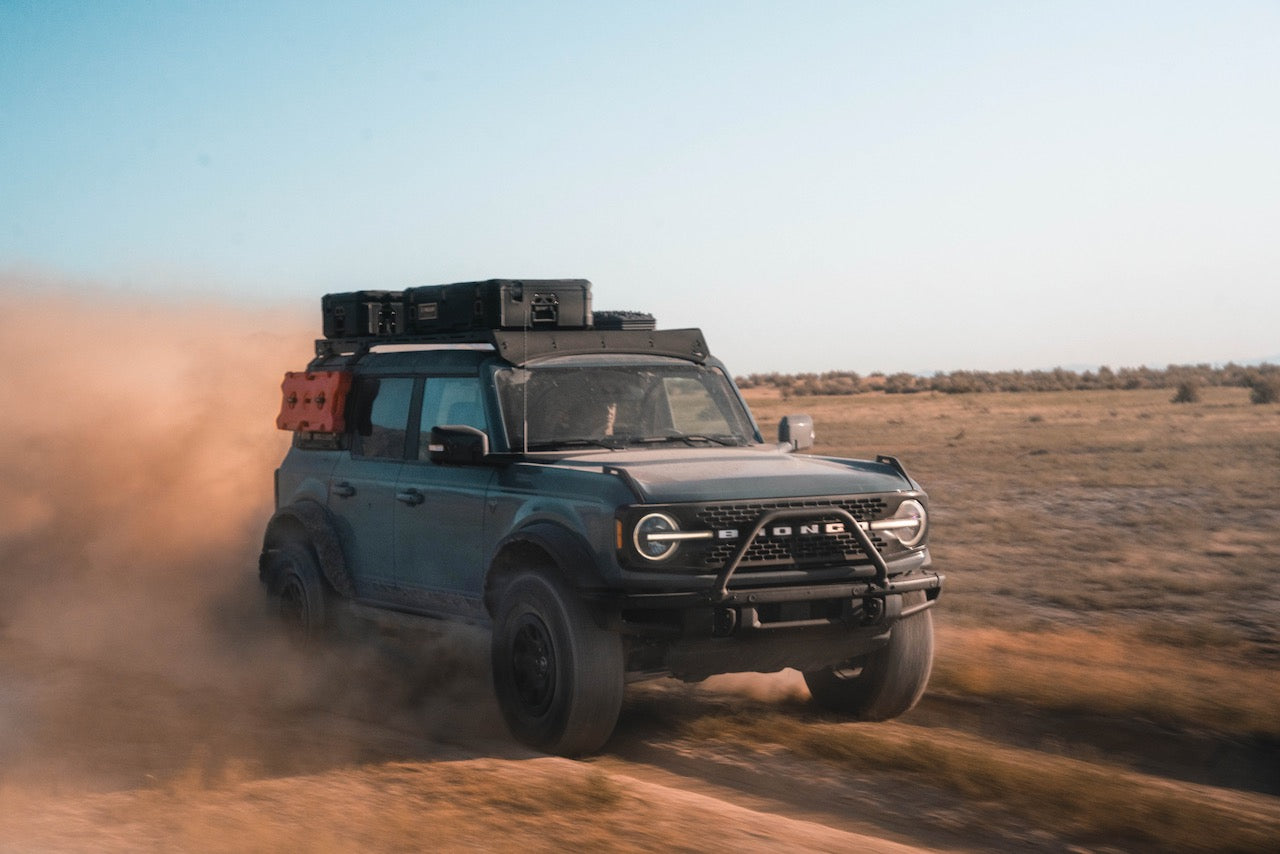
751,388,1280,737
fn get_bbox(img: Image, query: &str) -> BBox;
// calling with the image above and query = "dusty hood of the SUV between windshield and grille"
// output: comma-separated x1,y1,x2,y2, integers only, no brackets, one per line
545,447,916,503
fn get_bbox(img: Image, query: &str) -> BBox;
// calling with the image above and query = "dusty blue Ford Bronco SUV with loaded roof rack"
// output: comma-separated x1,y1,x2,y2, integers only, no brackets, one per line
259,279,943,755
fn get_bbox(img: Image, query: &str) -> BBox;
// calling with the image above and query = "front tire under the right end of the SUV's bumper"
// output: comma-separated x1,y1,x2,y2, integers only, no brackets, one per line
804,594,933,721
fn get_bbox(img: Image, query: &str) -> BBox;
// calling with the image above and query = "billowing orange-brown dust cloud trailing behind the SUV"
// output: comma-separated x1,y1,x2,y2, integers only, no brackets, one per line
0,275,497,787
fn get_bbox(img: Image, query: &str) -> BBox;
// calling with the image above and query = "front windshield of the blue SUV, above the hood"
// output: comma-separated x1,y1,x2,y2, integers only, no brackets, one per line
497,359,756,451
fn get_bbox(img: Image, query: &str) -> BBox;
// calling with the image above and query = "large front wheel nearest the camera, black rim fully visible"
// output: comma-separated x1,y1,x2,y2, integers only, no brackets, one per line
492,572,623,757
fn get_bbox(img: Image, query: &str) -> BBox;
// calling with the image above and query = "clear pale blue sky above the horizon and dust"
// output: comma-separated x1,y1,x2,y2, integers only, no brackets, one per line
0,0,1280,374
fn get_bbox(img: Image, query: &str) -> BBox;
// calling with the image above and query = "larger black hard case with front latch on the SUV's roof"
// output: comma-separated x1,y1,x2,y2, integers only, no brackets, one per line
404,279,591,334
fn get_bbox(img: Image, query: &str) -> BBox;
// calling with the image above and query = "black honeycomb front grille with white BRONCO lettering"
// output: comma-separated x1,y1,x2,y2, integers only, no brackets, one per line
686,498,887,572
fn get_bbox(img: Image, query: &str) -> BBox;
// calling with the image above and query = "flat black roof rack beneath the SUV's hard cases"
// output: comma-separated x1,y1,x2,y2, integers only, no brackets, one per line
312,329,710,366
